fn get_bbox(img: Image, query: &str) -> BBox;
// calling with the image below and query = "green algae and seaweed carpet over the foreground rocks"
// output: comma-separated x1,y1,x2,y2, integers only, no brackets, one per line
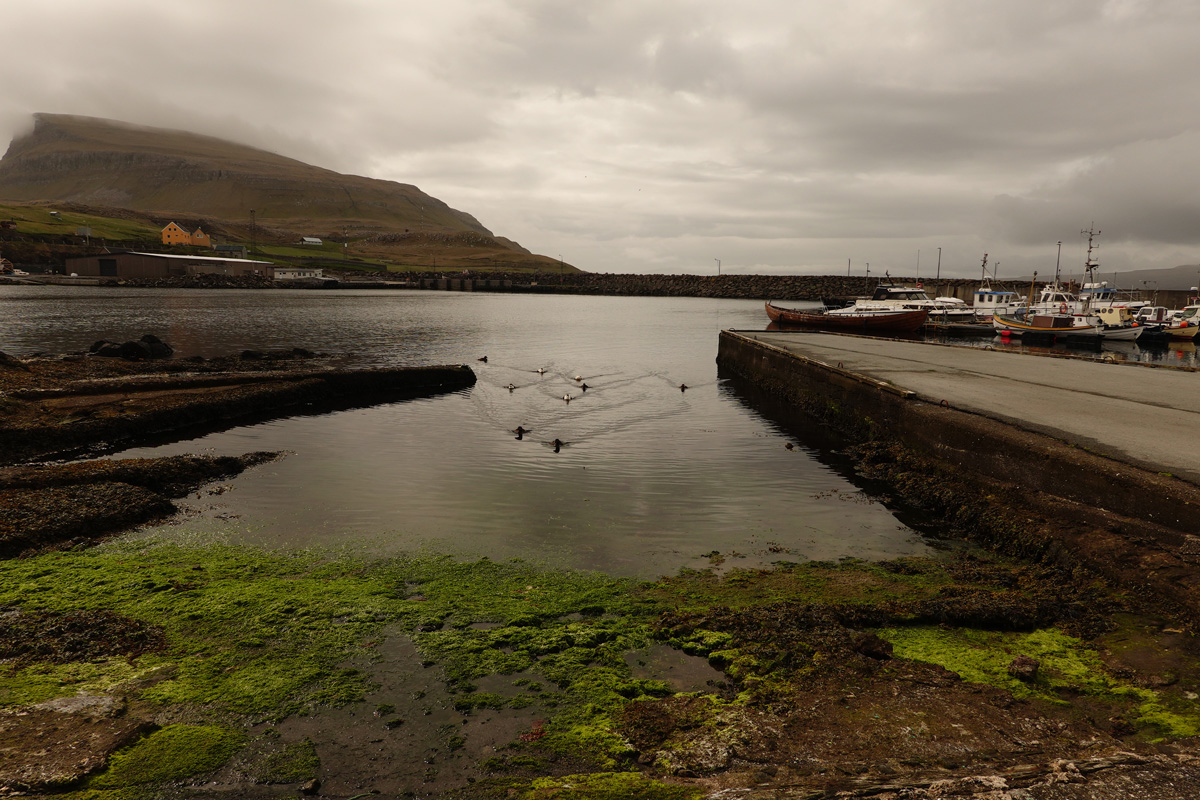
0,542,1196,798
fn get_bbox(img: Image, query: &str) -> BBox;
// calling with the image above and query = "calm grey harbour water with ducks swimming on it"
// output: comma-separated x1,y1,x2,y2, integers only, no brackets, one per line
0,287,930,577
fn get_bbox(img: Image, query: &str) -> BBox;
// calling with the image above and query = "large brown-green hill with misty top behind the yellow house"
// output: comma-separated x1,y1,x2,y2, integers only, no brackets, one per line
0,114,574,271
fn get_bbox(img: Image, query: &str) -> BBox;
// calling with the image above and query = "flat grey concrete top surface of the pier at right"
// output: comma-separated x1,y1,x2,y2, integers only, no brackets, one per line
720,331,1200,485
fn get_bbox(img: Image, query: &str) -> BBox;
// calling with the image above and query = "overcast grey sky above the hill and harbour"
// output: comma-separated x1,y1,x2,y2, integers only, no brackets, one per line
0,0,1200,279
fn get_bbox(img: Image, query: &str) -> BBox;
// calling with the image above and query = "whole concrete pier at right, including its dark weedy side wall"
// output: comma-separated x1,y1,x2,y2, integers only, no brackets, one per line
718,330,1200,618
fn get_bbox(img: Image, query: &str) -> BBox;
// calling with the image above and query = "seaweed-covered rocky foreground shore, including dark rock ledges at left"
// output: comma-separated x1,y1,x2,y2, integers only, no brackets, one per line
0,351,1200,800
